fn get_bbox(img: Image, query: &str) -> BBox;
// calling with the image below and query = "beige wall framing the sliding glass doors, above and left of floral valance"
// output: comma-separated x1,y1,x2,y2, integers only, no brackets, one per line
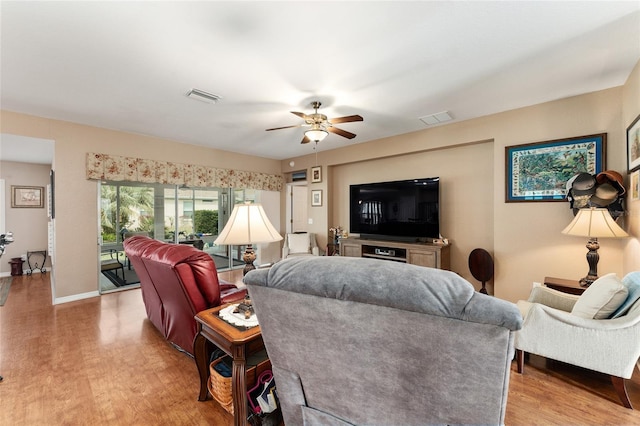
0,111,280,302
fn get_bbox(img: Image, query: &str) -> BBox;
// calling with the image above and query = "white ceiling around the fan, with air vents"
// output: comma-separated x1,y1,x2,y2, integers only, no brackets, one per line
0,1,640,163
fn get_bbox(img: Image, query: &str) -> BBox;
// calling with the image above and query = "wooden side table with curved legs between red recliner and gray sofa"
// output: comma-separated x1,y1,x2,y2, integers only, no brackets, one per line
193,304,264,426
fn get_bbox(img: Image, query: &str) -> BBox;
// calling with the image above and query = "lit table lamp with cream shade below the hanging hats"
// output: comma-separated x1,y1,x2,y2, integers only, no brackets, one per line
562,207,629,287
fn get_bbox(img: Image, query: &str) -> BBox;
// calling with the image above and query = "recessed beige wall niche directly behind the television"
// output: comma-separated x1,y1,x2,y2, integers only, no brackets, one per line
330,142,494,282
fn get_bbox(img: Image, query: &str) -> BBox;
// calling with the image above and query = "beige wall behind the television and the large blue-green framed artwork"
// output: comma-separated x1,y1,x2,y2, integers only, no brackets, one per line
282,60,640,301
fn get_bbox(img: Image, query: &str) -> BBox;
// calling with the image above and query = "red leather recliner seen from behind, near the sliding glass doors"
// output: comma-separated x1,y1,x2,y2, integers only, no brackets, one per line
123,236,247,355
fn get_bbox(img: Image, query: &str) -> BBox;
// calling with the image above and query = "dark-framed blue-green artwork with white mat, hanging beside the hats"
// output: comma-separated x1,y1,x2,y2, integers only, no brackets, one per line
505,133,607,203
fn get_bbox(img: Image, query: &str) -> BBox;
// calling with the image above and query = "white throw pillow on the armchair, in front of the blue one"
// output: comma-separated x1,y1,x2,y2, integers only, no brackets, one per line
571,273,629,319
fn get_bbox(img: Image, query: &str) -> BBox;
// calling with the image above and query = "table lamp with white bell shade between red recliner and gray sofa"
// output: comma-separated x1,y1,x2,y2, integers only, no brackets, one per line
214,203,282,275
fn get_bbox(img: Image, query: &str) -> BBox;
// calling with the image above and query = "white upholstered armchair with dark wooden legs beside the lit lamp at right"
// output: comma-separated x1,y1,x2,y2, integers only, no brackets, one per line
515,272,640,409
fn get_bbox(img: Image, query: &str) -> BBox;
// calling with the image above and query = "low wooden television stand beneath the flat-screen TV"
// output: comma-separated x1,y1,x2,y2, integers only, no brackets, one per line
340,238,450,270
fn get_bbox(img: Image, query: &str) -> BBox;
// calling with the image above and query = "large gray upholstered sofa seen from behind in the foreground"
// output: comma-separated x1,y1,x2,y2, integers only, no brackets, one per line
245,256,522,426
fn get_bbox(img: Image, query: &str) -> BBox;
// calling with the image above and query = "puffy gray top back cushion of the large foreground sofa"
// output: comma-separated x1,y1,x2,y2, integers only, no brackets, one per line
244,256,522,330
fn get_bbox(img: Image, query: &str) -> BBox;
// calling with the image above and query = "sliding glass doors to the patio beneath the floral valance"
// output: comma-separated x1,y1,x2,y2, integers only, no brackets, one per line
99,182,258,292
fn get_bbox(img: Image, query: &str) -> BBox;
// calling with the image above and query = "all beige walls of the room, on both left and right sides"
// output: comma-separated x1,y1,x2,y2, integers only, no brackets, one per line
0,59,640,301
